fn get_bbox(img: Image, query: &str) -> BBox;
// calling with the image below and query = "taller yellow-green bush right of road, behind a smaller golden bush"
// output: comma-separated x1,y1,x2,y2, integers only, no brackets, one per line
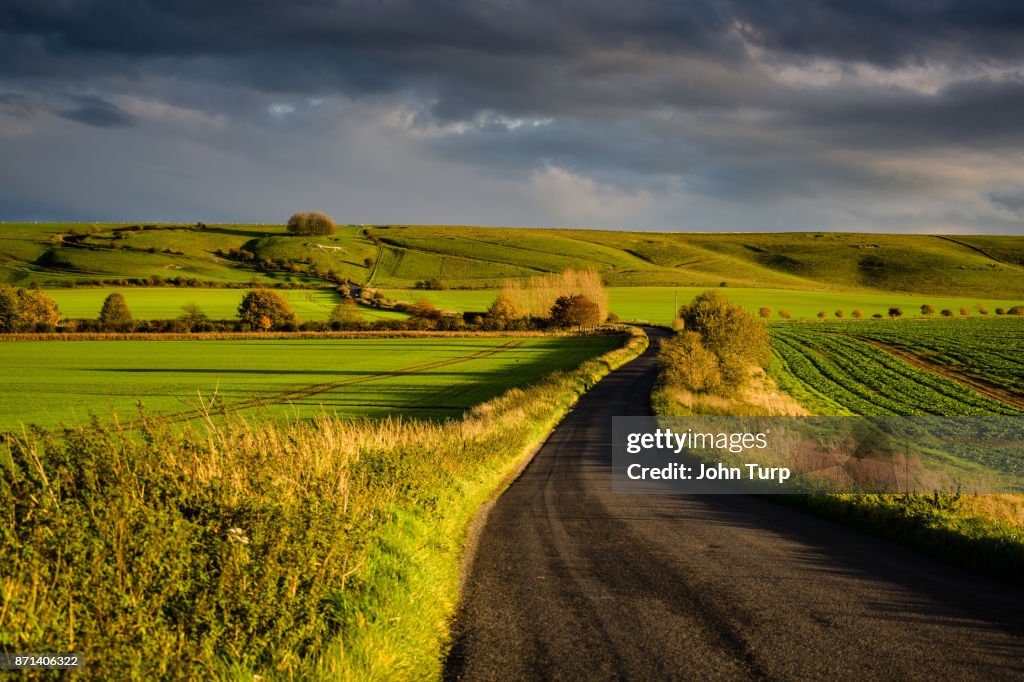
679,291,771,390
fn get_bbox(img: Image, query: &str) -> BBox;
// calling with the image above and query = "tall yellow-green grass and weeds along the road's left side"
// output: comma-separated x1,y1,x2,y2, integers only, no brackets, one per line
0,323,647,680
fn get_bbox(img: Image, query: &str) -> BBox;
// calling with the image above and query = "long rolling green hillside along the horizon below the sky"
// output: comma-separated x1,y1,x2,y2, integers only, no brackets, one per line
0,223,1024,298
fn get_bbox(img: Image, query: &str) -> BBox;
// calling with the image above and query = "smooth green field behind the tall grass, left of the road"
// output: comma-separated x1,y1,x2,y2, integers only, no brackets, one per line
0,337,621,430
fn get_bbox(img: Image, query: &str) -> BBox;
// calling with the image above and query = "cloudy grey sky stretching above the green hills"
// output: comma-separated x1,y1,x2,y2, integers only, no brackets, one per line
0,0,1024,235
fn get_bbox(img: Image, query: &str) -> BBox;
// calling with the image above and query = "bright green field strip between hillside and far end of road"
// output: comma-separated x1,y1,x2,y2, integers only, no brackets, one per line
382,287,1024,324
